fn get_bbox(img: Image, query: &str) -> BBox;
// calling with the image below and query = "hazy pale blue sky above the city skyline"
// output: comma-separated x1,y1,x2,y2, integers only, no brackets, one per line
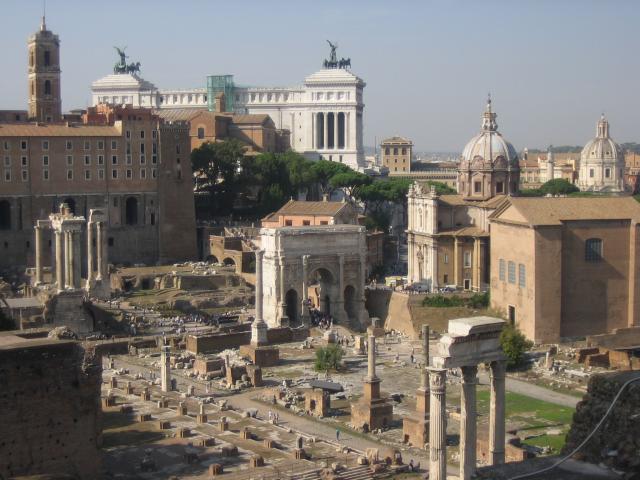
0,0,640,152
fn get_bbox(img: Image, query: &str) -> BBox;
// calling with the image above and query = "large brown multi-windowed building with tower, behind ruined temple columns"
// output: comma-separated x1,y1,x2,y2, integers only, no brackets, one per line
0,22,196,268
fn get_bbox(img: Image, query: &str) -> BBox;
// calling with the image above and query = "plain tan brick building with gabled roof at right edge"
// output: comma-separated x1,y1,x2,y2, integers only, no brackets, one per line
490,197,640,343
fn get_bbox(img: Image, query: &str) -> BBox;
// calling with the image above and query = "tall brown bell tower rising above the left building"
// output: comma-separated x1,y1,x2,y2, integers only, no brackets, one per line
28,16,62,123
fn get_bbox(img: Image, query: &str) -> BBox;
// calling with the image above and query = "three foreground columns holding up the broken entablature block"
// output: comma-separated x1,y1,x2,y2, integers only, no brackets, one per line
429,360,506,480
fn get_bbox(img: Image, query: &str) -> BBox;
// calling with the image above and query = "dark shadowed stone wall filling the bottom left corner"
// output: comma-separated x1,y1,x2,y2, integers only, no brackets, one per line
0,340,102,479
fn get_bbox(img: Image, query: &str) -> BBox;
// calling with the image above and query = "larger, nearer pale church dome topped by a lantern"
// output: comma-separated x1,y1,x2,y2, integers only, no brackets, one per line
460,98,518,168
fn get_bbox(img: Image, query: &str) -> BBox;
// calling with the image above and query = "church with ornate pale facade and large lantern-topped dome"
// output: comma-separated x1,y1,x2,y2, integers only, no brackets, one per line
407,98,520,291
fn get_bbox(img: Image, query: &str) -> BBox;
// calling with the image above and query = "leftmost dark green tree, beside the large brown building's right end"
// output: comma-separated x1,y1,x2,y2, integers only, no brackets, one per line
191,139,247,215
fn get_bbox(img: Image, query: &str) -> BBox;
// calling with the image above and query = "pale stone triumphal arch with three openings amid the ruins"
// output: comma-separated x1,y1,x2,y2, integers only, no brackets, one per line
260,225,369,327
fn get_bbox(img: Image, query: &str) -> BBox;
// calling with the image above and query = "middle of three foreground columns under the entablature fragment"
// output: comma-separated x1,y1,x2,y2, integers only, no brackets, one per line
460,365,478,480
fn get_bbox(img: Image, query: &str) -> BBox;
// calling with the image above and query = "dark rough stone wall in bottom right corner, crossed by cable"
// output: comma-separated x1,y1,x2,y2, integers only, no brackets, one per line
562,372,640,472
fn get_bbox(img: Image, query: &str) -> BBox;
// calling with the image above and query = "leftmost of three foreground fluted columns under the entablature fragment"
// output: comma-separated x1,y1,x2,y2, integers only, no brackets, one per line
429,367,447,480
